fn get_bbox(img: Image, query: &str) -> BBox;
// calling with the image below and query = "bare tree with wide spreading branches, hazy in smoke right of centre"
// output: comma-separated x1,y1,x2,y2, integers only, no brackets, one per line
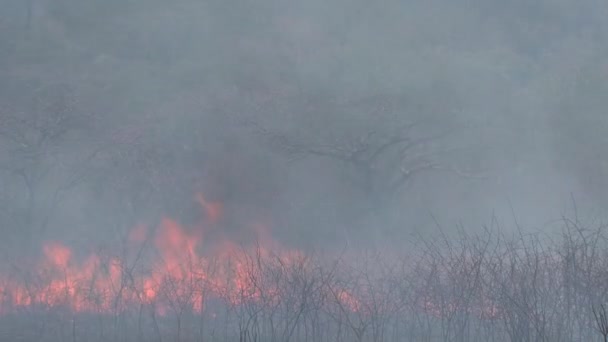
249,98,458,204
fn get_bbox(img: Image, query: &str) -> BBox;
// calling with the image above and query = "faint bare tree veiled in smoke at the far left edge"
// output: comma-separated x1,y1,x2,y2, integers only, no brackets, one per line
0,87,109,246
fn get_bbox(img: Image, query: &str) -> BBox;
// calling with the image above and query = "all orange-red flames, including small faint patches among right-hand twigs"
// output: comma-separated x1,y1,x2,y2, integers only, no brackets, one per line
0,195,501,319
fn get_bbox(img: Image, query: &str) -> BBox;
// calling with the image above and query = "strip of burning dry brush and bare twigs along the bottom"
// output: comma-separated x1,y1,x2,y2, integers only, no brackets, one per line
5,212,608,341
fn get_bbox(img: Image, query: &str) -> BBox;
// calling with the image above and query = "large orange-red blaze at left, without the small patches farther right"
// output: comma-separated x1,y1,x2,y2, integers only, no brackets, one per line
0,195,308,314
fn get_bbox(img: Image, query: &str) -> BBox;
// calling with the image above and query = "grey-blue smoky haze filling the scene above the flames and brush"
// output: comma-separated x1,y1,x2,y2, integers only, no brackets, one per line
0,0,608,254
